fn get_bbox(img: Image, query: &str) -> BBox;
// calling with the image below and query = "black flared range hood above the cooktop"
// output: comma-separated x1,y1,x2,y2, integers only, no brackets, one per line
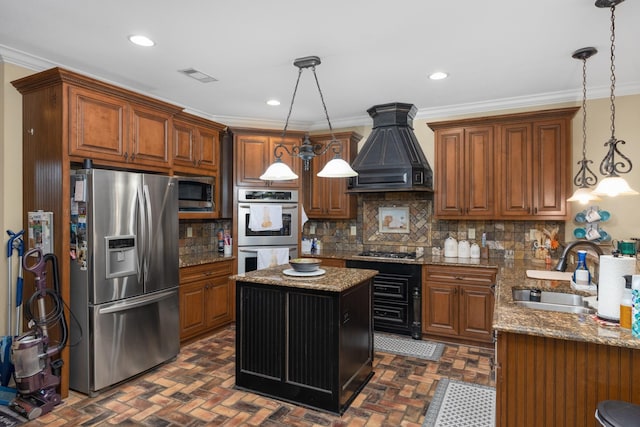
348,102,433,193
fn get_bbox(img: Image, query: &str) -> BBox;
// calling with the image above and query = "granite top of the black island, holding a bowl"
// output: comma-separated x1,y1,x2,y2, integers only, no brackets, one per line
229,265,378,292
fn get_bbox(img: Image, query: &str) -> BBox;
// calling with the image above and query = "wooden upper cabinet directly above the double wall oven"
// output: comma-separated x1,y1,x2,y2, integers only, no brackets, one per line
233,129,302,189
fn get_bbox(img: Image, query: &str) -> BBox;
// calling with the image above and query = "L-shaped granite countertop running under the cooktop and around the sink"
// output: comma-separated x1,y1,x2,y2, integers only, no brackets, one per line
304,251,640,349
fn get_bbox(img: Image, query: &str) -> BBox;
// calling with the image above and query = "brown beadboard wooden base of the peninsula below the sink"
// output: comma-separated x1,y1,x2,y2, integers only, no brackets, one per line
496,332,640,427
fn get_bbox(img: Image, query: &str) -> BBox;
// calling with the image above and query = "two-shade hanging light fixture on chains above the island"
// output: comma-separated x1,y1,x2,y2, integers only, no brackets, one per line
260,56,358,181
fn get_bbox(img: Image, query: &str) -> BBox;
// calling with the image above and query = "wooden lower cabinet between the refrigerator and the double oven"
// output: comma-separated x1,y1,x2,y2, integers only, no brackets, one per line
180,260,235,341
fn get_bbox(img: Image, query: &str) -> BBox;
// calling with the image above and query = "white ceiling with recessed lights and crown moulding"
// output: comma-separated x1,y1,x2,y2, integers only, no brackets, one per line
0,0,640,130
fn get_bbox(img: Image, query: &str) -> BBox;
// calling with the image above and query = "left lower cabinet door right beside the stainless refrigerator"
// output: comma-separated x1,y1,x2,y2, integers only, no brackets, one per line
179,281,207,340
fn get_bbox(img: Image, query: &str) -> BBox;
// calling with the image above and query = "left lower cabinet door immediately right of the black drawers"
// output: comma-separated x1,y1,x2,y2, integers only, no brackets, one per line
422,283,458,336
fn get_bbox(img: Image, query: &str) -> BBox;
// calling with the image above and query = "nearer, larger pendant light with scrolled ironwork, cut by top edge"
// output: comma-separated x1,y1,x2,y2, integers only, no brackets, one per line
593,0,639,197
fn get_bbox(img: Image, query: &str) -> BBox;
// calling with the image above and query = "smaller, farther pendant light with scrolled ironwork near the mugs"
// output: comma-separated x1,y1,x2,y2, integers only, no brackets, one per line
567,47,600,205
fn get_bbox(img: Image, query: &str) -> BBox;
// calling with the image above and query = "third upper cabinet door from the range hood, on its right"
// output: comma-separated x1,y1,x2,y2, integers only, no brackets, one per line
499,123,533,217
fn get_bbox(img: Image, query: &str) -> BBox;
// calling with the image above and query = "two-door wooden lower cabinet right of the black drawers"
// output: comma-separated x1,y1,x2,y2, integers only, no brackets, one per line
422,265,497,343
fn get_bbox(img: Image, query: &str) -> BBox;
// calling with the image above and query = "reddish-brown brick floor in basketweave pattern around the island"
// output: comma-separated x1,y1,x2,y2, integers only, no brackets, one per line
28,325,494,427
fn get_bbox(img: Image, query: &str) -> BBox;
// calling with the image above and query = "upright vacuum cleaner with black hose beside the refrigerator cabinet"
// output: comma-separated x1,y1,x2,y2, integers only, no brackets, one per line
9,248,68,420
